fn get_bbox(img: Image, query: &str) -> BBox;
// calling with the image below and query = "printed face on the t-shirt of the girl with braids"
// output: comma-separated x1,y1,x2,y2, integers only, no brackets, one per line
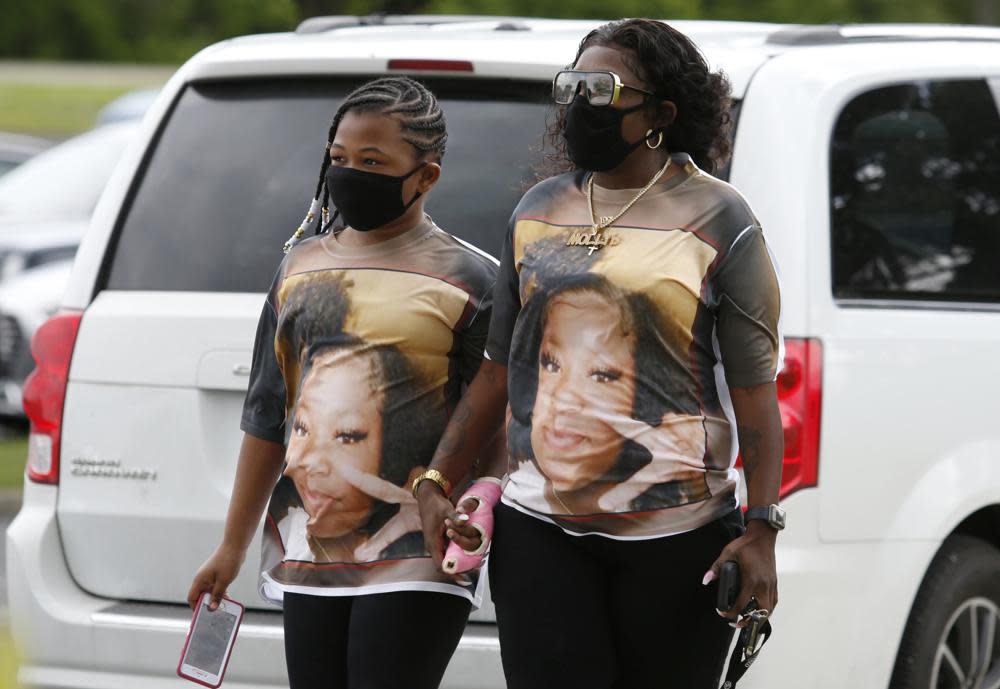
285,348,383,538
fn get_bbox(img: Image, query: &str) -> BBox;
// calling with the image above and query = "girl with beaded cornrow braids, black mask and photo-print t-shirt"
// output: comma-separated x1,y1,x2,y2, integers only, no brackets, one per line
188,77,496,689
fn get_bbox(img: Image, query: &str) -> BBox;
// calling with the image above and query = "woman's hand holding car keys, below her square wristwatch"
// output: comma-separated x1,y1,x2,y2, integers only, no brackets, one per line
702,520,778,628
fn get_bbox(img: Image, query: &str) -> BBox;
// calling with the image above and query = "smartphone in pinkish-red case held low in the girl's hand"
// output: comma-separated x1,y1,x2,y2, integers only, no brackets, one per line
177,593,244,688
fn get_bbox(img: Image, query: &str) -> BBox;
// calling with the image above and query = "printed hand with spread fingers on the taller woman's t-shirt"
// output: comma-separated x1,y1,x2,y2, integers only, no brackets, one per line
597,413,705,512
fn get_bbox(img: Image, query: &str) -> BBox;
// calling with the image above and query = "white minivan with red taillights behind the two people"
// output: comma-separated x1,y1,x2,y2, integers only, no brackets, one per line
7,17,1000,689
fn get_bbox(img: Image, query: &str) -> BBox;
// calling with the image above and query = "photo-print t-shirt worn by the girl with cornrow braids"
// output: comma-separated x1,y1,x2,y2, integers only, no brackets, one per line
241,218,497,605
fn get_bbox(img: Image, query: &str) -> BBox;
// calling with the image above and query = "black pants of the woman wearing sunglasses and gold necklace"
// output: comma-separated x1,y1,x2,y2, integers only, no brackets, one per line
490,505,743,689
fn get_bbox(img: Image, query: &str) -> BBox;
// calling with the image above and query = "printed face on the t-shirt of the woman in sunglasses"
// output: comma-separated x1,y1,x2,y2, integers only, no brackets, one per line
531,290,635,491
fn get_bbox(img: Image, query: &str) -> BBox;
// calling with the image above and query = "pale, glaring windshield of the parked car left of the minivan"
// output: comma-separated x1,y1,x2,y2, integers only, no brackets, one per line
0,123,137,220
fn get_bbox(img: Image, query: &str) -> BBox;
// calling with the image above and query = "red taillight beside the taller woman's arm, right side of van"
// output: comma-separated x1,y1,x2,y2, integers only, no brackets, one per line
777,338,823,498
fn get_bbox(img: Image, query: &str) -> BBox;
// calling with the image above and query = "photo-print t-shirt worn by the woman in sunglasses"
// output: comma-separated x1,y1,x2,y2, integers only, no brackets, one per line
486,153,783,539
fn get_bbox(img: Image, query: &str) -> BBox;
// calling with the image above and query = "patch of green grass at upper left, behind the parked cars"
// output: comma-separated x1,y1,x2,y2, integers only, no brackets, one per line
0,82,131,139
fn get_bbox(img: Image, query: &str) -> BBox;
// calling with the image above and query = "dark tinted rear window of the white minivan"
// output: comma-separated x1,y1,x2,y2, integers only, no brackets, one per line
107,78,549,291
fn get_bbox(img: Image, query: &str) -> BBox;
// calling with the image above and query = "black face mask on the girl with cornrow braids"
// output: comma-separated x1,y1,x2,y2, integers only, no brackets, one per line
326,163,427,232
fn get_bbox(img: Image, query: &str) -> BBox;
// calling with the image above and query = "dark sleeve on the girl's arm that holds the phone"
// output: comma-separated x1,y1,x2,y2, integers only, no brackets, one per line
240,279,285,444
